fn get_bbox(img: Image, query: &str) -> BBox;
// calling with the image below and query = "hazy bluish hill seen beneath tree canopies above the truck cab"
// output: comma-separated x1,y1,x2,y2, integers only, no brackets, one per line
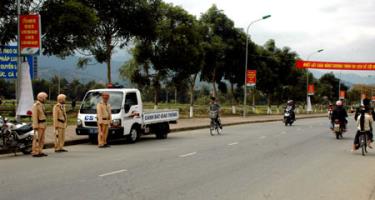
38,55,130,84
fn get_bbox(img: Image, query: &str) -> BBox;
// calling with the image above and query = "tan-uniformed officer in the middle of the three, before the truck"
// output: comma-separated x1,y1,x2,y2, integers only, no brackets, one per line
53,94,68,152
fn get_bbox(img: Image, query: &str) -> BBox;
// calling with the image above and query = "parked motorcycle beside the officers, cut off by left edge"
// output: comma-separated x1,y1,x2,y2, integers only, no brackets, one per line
0,116,34,154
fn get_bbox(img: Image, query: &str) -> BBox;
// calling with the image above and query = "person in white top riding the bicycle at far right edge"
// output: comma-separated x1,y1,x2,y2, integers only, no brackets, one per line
352,105,373,151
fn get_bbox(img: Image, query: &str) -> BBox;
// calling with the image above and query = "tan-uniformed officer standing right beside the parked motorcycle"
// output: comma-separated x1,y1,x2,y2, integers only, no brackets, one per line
31,92,48,157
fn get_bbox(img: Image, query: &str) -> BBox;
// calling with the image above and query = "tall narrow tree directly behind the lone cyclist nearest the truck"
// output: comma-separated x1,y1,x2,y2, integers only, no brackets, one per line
200,5,235,96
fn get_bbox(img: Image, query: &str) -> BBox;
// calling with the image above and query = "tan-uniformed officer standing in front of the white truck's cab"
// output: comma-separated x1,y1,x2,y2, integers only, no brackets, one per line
96,92,112,148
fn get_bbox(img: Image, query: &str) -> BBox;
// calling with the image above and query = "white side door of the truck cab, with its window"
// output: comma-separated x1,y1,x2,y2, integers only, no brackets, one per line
123,92,142,135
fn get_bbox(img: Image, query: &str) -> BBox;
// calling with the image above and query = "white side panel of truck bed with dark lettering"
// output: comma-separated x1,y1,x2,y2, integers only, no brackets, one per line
142,109,179,124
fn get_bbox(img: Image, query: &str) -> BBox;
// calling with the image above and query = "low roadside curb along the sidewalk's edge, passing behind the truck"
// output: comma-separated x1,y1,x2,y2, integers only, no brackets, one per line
0,115,326,154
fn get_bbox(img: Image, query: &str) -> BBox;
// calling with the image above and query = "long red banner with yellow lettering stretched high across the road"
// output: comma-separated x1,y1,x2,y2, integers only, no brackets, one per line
296,60,375,70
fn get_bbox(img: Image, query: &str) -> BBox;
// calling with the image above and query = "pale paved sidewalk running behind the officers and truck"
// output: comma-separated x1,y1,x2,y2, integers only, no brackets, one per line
41,114,327,148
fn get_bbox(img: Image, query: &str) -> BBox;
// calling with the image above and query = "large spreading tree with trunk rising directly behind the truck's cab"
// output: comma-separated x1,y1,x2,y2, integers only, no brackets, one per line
41,0,160,83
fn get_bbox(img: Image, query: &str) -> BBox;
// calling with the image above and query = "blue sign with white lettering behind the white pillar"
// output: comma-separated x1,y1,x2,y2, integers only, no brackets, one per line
0,46,34,79
